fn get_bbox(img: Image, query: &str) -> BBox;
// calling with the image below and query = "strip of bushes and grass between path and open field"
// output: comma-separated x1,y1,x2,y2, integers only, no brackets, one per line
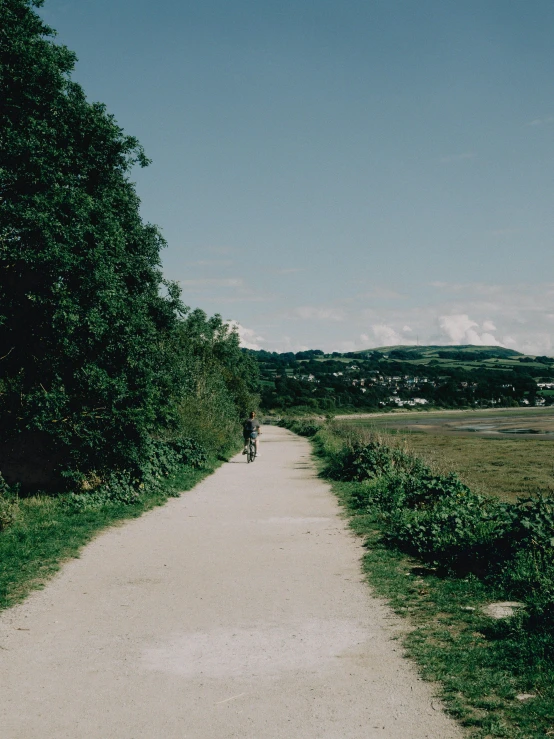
283,419,554,739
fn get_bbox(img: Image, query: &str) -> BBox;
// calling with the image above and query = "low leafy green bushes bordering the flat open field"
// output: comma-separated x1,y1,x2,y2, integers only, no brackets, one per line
306,422,554,628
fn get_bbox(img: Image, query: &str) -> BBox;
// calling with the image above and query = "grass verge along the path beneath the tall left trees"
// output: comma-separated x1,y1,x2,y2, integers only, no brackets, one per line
0,458,221,610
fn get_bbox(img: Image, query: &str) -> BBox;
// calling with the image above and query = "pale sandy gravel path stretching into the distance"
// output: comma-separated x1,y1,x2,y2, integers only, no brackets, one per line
0,427,462,739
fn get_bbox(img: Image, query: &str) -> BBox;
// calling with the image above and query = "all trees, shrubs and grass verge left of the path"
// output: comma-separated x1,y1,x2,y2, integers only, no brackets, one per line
0,0,258,605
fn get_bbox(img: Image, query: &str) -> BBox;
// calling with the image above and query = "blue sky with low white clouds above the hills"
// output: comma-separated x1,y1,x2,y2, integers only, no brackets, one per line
40,0,554,355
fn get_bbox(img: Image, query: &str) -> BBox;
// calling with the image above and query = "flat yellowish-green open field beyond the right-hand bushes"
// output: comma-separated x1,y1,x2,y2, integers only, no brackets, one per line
341,408,554,501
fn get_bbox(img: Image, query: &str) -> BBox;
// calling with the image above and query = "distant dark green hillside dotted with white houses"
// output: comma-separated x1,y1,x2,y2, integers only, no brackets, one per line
249,345,554,412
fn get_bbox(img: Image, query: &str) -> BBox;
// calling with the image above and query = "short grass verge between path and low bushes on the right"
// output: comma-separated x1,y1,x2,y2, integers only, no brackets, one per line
333,483,554,739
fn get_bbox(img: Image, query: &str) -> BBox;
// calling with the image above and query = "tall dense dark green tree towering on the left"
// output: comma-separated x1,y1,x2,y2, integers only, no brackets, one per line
0,0,182,486
